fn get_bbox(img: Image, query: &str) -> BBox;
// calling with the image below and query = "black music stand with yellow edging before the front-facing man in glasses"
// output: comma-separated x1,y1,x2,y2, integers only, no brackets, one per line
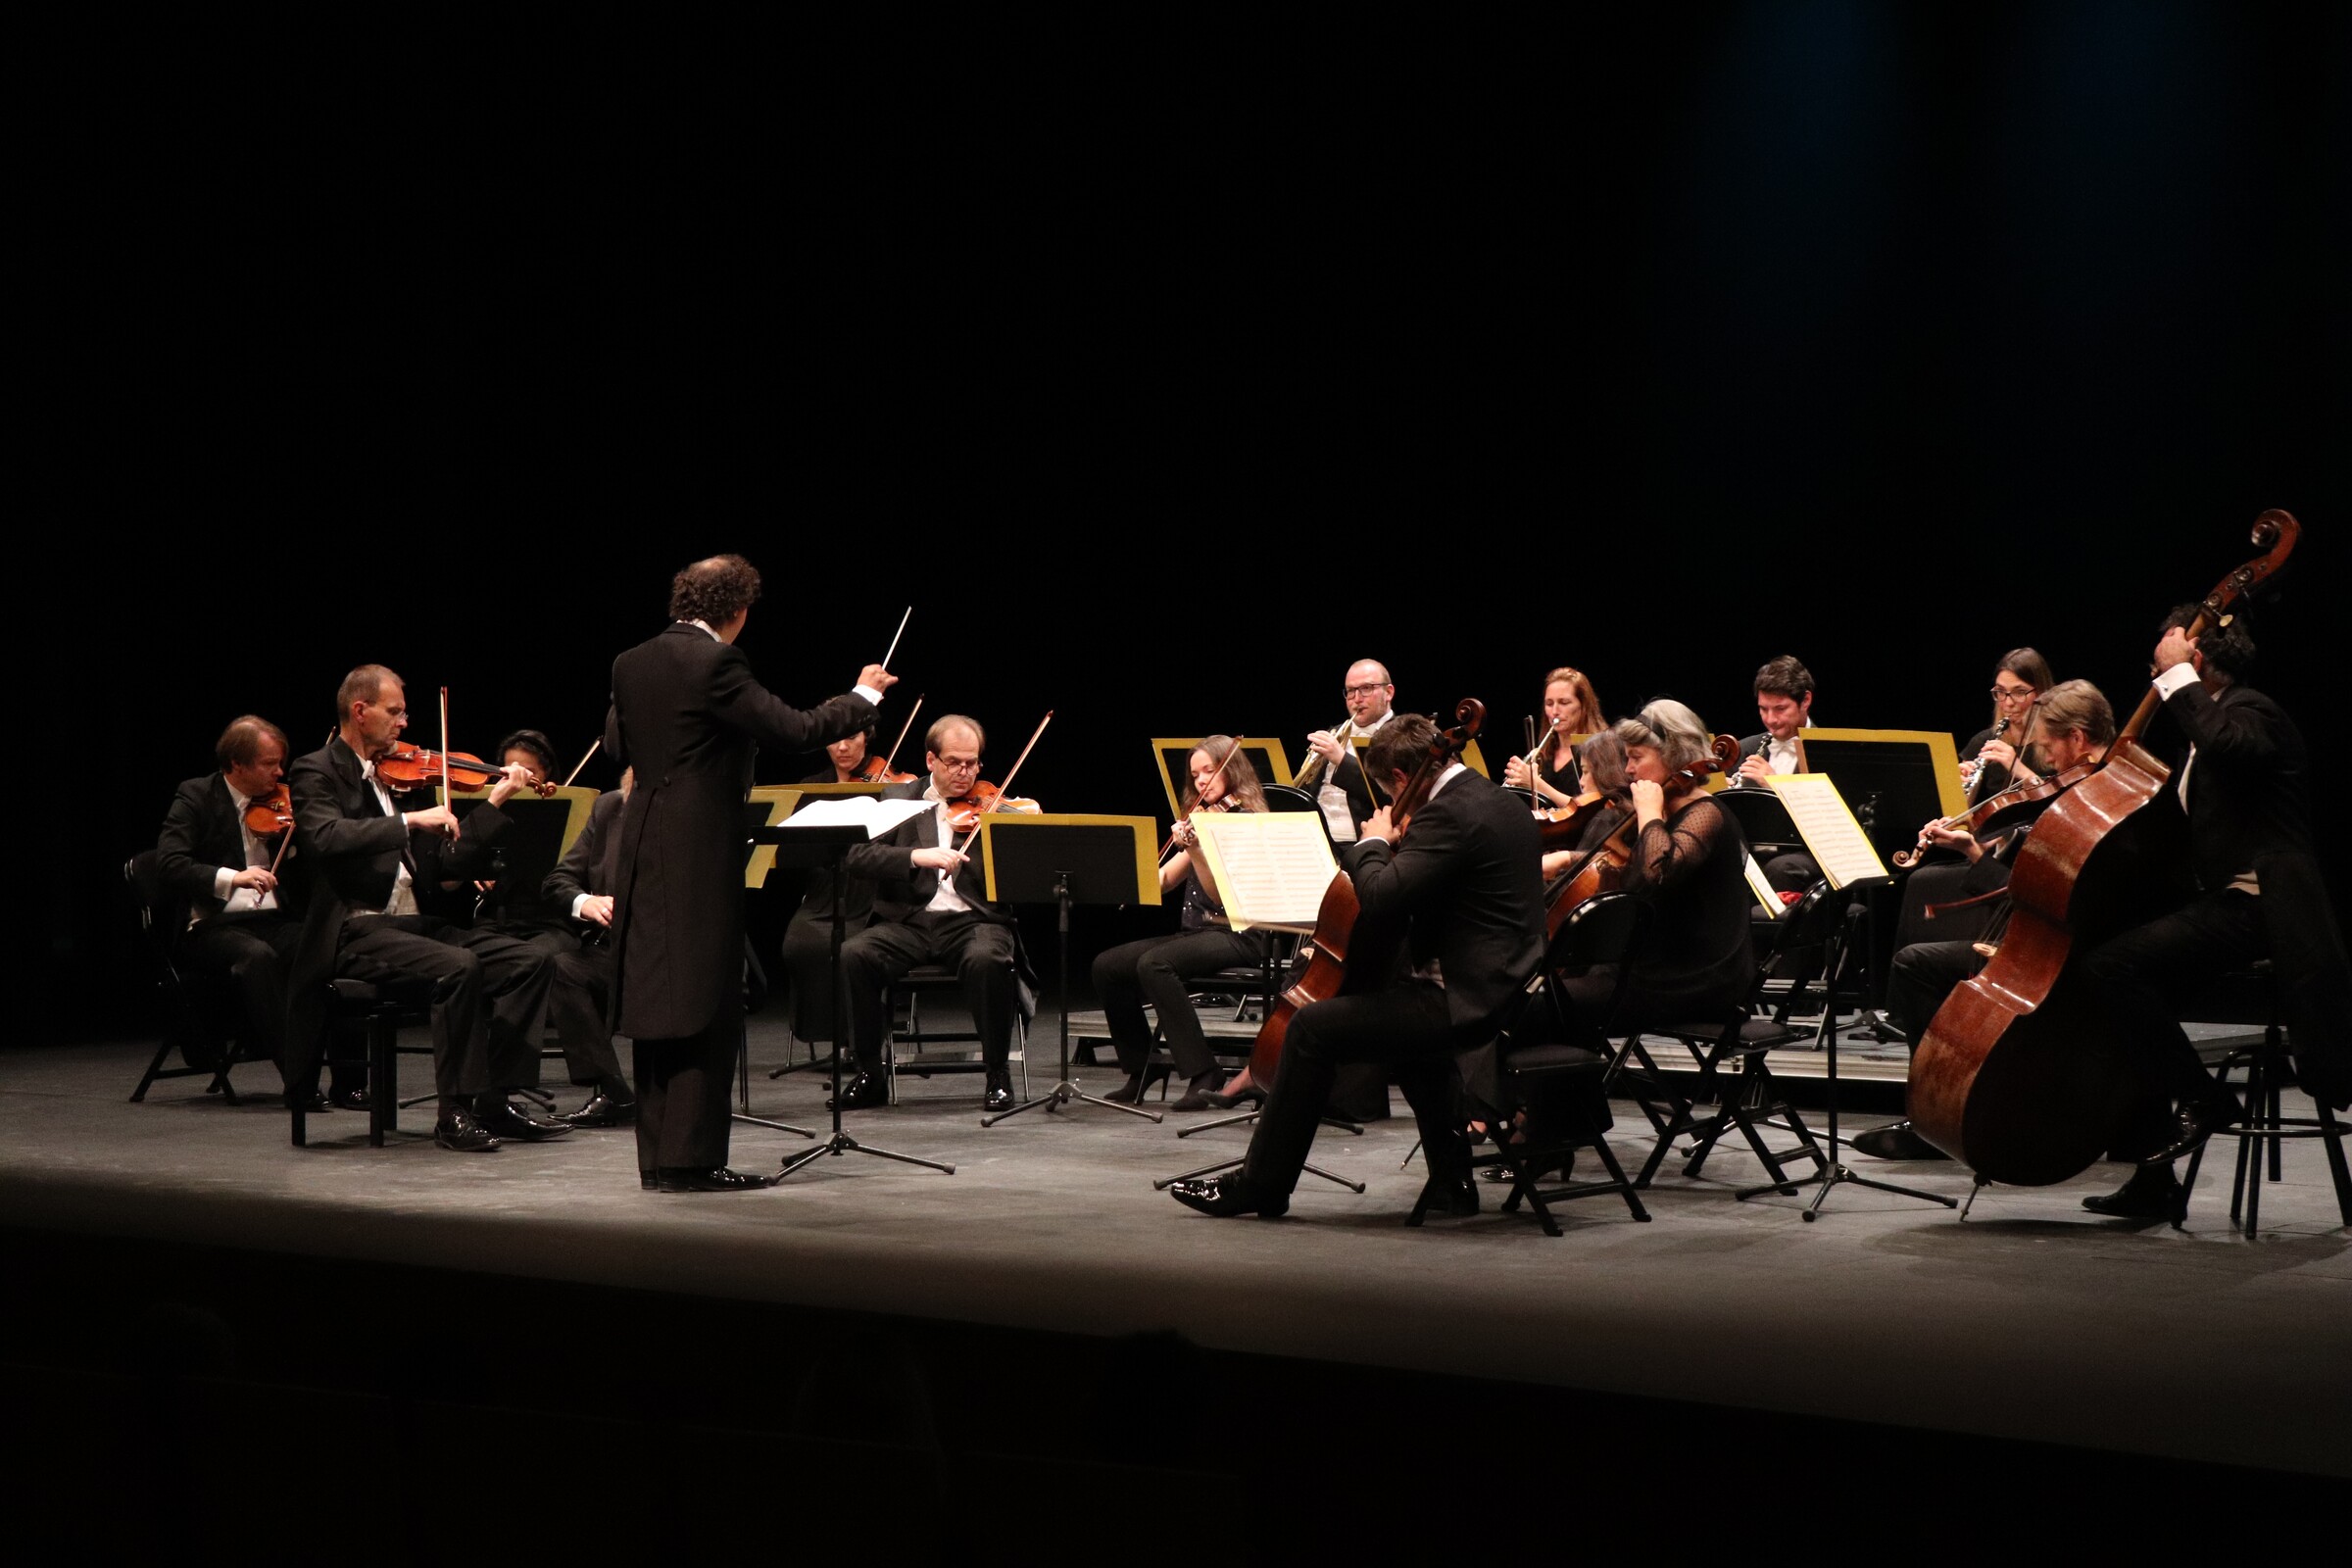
981,811,1162,1126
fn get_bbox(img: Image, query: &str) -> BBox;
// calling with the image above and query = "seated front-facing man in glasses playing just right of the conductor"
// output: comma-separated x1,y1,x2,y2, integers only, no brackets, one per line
842,712,1037,1112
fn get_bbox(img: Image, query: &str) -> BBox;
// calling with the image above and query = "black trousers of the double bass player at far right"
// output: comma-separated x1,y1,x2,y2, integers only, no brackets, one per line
2082,889,2270,1156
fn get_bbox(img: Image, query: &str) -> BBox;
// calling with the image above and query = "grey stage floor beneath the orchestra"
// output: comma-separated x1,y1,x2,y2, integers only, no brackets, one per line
0,1020,2352,1474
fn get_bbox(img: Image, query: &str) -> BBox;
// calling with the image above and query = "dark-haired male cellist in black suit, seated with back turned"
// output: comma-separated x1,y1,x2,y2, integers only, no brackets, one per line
1169,714,1543,1218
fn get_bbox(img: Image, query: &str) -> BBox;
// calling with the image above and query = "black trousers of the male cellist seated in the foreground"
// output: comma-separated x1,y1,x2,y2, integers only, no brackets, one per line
1242,980,1470,1192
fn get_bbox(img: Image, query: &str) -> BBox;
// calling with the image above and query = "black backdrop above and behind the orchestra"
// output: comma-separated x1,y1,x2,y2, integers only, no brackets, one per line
36,0,2352,1037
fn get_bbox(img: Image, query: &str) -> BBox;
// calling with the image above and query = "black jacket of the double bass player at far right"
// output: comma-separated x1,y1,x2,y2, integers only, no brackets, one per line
2164,684,2352,1109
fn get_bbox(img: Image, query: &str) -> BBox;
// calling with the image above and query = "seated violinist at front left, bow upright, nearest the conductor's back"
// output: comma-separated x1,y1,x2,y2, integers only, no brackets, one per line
287,665,571,1154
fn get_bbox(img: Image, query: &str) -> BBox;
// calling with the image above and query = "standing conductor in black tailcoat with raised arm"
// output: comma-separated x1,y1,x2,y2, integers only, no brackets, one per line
605,555,896,1192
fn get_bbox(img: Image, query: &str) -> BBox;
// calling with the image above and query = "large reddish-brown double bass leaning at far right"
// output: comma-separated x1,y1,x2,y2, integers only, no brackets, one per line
1907,511,2303,1187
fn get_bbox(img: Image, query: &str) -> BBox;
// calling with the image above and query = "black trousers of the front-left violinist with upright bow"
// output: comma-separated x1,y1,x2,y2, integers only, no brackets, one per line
334,914,553,1109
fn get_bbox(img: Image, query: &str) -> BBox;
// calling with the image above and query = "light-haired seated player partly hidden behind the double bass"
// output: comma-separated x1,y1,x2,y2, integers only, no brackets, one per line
1853,679,2115,1159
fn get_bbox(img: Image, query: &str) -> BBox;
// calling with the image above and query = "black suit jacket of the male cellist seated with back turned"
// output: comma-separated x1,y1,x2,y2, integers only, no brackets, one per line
1346,768,1543,1051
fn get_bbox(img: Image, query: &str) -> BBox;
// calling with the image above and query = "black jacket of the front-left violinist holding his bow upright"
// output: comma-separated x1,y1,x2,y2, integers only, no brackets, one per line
277,736,506,1089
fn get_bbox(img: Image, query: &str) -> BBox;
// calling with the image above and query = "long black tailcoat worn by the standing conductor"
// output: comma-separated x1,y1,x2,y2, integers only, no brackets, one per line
605,623,872,1039
